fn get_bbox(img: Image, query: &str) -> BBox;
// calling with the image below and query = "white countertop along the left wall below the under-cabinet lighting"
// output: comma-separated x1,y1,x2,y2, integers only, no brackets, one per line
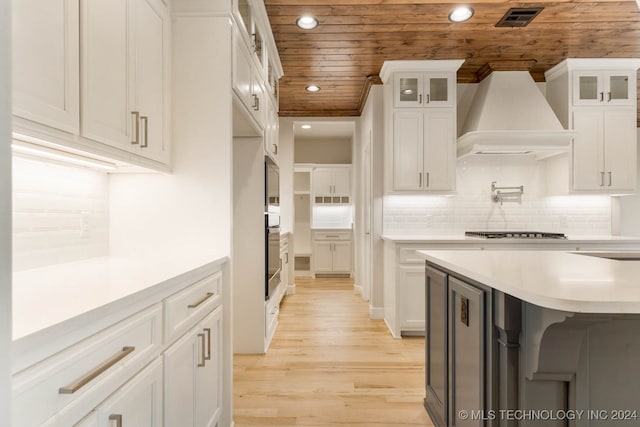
13,251,227,341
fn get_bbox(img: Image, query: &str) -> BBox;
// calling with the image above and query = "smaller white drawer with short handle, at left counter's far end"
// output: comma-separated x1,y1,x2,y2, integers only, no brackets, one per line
164,272,222,343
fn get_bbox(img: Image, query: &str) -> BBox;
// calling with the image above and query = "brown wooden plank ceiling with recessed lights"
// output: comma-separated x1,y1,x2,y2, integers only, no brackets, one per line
265,0,640,117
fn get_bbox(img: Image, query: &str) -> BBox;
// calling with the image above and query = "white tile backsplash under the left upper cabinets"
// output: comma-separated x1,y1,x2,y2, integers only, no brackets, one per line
13,156,109,271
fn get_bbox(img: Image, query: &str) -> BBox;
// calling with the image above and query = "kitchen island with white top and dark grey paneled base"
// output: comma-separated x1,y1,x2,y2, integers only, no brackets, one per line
419,250,640,426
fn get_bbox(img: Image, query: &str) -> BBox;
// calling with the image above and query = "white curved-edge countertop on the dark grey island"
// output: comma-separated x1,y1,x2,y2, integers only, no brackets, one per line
418,250,640,313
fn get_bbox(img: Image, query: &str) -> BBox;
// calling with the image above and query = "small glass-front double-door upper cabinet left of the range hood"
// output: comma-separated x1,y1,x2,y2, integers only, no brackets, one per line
393,72,456,108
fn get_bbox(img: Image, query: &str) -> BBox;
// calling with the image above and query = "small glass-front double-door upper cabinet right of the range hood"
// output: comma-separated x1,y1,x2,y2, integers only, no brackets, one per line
573,70,636,105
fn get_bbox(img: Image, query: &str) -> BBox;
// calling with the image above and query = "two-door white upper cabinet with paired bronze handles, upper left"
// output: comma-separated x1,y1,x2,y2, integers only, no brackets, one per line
81,0,169,163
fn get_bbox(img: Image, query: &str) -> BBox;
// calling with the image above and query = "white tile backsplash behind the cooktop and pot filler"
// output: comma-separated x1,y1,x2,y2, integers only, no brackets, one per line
384,156,611,235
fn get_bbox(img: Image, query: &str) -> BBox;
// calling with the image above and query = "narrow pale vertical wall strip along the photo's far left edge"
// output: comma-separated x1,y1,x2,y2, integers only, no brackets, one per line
0,0,11,426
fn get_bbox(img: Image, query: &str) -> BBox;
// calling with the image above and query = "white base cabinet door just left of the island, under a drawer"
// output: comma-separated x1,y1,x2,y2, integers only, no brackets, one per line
398,264,425,332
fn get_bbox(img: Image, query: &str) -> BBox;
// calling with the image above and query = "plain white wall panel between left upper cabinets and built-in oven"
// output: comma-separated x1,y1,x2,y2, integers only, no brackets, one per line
111,17,232,256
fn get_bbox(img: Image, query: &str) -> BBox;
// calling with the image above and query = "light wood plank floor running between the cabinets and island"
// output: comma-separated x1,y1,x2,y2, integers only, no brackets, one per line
234,278,432,427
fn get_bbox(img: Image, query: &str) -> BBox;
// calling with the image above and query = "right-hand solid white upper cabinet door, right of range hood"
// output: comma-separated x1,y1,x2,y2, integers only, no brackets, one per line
604,109,637,192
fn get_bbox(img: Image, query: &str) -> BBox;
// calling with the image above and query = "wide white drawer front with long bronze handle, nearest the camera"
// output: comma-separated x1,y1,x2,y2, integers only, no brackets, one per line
13,304,162,427
